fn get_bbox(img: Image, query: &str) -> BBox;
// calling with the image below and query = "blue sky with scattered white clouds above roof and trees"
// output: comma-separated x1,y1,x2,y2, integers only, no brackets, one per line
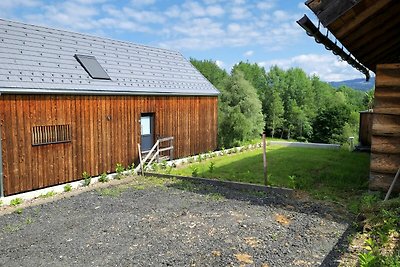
0,0,363,81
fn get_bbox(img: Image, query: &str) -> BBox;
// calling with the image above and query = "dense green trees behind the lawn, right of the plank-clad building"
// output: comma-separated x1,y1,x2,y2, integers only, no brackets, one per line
190,59,373,147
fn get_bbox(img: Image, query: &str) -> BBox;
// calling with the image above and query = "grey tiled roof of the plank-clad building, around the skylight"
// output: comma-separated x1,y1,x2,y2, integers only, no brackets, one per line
0,19,218,95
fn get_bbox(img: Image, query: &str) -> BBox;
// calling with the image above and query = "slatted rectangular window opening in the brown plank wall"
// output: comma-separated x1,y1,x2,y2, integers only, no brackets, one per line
32,124,71,146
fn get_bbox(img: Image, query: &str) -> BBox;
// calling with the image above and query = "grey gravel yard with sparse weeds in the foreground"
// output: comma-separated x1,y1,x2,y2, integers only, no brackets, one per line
0,177,349,267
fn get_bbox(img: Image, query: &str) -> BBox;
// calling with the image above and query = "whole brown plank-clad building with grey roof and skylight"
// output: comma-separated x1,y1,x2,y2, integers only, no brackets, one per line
0,20,219,196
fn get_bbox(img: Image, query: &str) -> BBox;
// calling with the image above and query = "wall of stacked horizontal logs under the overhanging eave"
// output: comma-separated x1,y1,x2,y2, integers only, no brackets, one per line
369,64,400,192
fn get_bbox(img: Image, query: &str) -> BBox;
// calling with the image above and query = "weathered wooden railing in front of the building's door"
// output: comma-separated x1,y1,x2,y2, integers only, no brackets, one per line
136,137,174,175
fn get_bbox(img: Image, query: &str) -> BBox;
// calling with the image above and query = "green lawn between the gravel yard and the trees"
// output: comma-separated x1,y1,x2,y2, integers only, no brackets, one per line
167,146,369,211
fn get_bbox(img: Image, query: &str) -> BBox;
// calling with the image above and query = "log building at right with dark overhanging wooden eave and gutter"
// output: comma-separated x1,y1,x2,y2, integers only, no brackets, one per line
298,0,400,192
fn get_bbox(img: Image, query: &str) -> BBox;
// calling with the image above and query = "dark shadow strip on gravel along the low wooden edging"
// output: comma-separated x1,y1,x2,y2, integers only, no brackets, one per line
166,179,351,223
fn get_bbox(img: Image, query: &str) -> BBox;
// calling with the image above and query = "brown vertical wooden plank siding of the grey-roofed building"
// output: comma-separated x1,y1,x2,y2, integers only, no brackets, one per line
0,94,217,195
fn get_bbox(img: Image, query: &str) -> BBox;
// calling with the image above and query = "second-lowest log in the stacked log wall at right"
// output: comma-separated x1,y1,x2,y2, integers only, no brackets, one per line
371,153,400,174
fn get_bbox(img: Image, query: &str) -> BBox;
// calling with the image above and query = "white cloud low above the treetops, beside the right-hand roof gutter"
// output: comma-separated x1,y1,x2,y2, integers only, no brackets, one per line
258,54,363,81
